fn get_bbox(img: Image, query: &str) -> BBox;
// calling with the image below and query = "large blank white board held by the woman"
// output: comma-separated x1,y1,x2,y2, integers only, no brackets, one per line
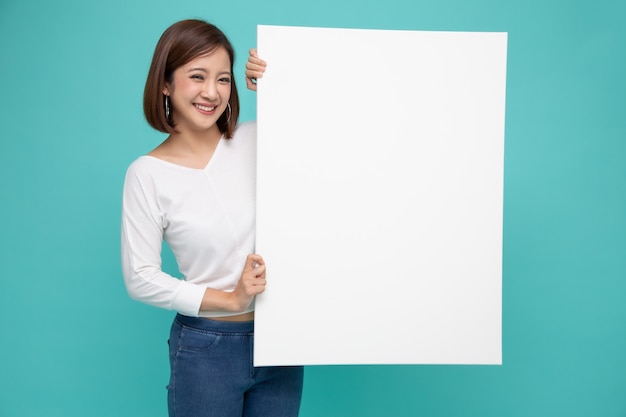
254,26,507,366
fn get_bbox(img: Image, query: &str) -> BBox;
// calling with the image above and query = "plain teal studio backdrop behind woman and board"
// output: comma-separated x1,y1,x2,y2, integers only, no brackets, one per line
0,0,626,417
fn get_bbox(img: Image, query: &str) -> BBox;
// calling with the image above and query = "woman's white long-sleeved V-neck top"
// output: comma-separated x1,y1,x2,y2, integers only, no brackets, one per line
122,123,256,317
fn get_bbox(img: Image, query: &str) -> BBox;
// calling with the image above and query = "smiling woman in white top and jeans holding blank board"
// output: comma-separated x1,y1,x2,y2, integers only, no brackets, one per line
122,20,303,417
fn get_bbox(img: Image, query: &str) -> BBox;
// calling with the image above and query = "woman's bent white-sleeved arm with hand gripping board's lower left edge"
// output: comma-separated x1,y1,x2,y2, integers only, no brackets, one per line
121,162,265,316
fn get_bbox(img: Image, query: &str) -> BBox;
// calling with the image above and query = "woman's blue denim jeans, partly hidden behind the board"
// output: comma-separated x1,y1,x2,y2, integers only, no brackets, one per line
167,314,304,417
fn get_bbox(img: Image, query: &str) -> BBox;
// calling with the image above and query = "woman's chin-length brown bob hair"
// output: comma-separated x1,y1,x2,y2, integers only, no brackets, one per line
143,20,239,139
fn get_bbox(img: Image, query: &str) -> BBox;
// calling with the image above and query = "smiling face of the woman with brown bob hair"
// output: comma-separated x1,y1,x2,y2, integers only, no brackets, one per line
163,48,232,134
